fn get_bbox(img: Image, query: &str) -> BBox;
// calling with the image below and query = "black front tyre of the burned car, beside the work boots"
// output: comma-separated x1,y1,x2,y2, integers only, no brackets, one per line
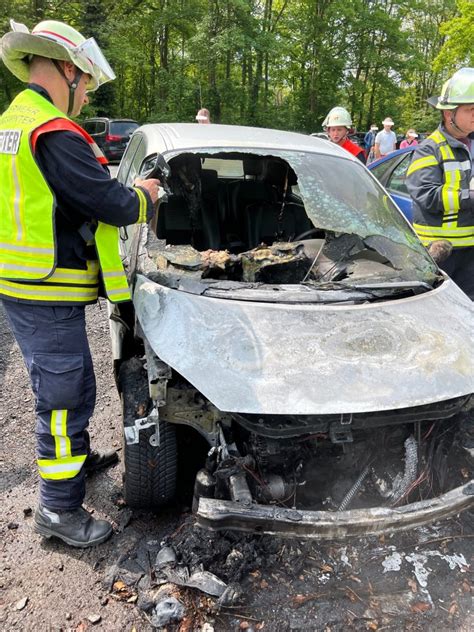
123,421,178,511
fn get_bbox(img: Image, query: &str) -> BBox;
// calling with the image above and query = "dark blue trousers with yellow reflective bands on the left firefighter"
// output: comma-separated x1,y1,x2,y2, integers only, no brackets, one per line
3,300,96,509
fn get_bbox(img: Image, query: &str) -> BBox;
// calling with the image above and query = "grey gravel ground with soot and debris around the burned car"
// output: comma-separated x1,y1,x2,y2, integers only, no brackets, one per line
0,303,474,632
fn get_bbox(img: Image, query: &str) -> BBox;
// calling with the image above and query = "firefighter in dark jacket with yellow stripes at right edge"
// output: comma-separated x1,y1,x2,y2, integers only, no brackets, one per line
406,68,474,300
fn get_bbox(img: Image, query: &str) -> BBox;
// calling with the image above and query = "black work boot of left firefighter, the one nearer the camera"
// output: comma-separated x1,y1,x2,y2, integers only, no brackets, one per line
33,505,112,549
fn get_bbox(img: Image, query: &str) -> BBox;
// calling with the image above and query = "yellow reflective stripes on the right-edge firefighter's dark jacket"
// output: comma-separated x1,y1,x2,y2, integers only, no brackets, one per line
407,129,474,248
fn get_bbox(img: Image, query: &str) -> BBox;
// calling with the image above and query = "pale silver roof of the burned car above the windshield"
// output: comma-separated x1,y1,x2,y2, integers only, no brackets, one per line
139,123,355,160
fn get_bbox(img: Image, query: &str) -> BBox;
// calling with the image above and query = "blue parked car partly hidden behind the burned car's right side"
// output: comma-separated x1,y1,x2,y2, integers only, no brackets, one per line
367,147,415,222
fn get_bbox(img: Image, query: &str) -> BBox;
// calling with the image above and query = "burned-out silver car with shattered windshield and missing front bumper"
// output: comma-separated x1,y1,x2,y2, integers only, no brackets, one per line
110,124,474,538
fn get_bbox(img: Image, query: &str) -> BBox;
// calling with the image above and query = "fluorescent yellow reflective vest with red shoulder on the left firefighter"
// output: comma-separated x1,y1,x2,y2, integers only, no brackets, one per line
0,89,147,304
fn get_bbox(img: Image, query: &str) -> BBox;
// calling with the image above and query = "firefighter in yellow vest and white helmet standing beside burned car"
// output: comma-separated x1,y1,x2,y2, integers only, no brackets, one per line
0,20,159,547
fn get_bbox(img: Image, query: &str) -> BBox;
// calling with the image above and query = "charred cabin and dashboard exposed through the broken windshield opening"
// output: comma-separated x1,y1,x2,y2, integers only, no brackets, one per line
145,152,431,292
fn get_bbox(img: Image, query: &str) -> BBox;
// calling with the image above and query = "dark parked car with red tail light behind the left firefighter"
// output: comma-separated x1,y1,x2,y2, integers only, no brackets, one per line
82,117,140,162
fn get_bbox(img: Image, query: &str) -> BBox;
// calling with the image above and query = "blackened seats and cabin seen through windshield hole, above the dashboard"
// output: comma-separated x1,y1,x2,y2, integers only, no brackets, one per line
150,154,314,253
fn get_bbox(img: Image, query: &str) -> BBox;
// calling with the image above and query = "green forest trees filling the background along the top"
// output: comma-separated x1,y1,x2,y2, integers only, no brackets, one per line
0,0,474,132
